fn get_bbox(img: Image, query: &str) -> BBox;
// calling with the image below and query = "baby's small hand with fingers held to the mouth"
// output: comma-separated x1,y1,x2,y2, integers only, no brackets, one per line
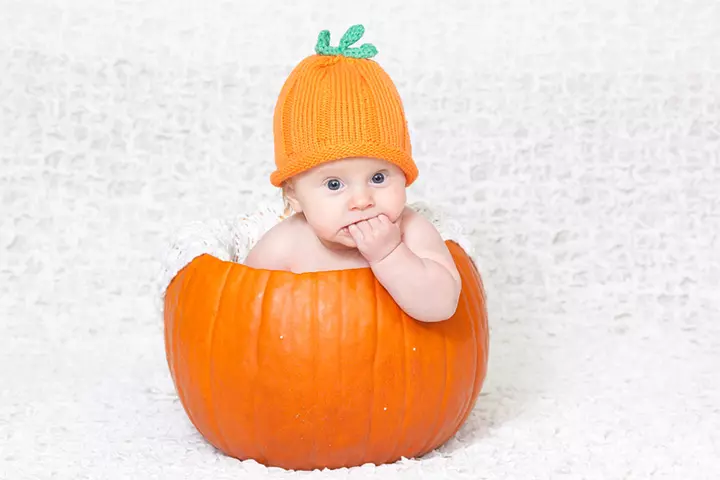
348,214,402,265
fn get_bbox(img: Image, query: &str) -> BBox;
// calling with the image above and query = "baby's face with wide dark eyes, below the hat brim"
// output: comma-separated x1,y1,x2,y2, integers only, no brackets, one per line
288,157,407,248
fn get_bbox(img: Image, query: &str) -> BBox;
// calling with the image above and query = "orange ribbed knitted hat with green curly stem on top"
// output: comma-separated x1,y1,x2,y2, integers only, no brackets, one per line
270,25,418,187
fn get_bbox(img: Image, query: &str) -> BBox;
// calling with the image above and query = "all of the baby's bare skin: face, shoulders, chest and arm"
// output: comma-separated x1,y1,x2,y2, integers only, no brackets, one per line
244,159,461,322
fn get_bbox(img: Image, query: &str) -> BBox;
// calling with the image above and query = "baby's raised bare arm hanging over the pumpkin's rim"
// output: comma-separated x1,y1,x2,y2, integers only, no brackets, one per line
348,211,461,322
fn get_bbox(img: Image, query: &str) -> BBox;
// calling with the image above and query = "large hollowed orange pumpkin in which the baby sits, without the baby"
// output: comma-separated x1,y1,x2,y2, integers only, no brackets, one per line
164,241,489,470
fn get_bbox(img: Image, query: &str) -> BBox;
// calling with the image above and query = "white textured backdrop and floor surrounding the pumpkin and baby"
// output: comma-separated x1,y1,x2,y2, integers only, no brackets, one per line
0,0,720,480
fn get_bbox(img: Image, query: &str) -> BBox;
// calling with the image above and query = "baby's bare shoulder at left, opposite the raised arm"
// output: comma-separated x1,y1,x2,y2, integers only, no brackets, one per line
243,216,303,270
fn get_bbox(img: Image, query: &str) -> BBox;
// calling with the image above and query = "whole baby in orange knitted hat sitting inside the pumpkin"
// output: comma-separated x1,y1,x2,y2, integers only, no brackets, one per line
244,25,461,322
